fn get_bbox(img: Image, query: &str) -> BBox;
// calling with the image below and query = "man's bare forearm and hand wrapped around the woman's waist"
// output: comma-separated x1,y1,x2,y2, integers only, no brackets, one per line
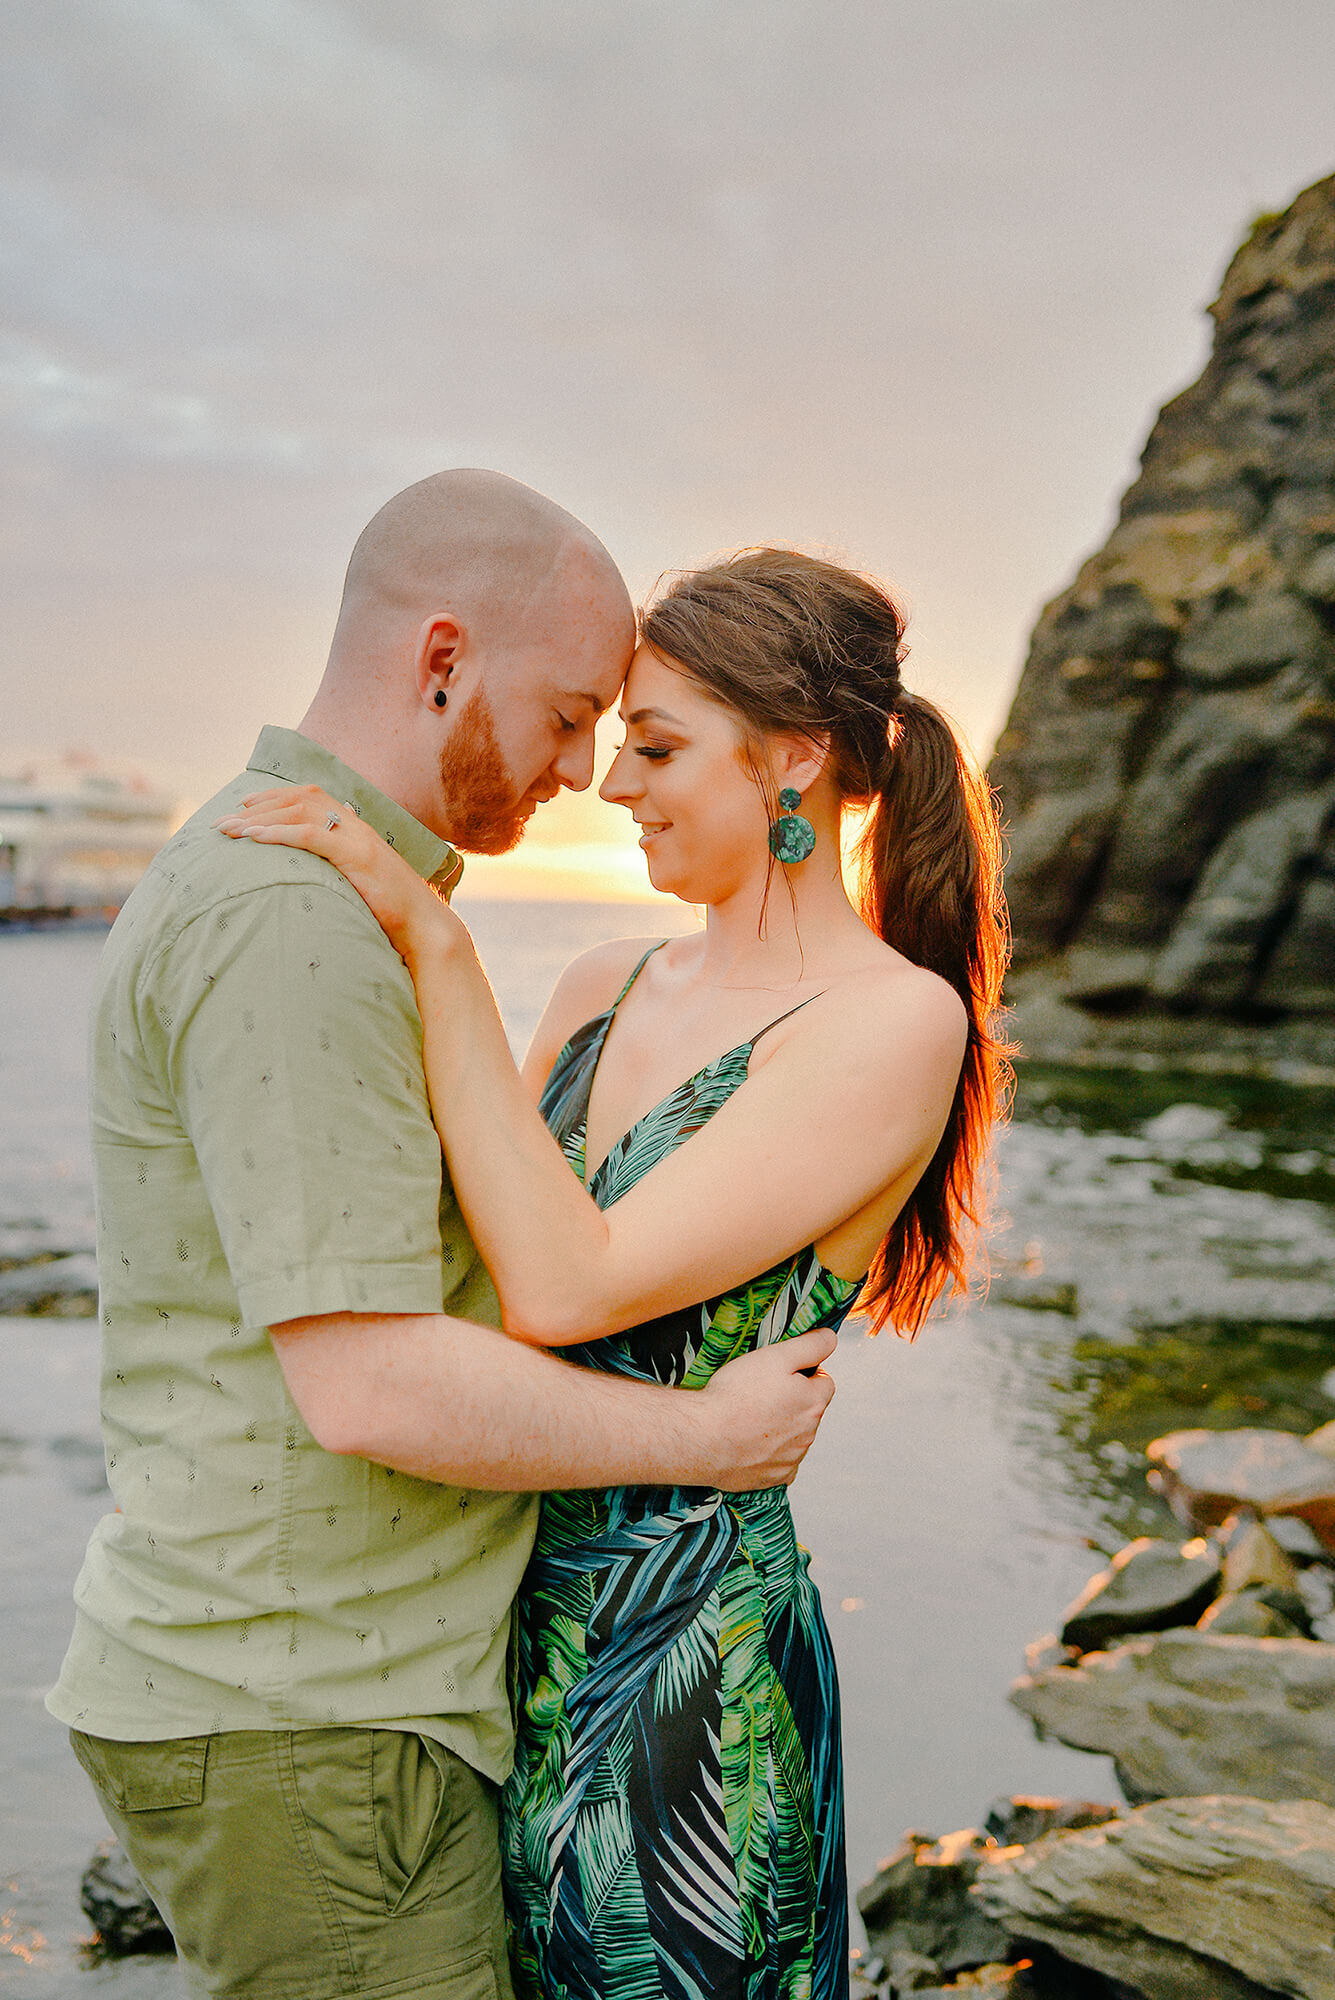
272,1312,835,1492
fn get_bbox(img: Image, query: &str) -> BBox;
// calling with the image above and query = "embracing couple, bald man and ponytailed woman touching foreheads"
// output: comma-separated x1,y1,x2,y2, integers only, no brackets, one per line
50,472,1005,2000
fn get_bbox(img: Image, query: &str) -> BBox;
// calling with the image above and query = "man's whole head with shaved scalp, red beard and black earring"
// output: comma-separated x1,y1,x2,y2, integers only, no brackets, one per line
302,470,636,852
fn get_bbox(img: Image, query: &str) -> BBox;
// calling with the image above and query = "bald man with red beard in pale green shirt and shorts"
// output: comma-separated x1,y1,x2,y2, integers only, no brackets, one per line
50,472,833,2000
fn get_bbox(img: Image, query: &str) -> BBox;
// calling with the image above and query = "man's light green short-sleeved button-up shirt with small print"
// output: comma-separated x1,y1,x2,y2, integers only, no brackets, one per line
48,728,536,1778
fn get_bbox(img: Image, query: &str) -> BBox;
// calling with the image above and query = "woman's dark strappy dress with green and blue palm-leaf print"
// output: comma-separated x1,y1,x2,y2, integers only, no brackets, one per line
502,954,857,2000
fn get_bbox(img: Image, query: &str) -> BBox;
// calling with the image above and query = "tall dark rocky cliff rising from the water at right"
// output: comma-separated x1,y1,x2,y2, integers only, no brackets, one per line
991,176,1335,1034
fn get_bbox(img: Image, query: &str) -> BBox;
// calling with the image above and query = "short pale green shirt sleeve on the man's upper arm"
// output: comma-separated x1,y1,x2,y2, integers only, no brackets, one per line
142,880,442,1326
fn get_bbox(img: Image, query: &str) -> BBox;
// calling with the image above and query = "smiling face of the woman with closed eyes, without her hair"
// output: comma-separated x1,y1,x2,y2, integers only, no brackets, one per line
600,646,769,902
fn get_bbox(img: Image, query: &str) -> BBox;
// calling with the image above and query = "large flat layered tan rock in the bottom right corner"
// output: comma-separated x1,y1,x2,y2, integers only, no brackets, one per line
973,1796,1335,2000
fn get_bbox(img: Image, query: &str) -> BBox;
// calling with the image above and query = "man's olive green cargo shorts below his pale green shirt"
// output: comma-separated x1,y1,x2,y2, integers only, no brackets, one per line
70,1728,512,2000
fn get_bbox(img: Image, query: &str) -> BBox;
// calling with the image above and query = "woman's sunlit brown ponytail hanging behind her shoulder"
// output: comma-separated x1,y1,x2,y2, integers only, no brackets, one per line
859,694,1011,1336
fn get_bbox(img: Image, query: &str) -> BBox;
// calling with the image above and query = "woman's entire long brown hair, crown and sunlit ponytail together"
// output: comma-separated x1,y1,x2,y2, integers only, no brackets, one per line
640,548,1011,1336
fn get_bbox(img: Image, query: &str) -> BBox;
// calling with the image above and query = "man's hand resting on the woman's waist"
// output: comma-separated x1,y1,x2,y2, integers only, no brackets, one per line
699,1328,837,1494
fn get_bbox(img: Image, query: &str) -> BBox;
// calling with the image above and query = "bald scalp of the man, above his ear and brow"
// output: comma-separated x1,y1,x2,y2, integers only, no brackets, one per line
330,468,634,678
